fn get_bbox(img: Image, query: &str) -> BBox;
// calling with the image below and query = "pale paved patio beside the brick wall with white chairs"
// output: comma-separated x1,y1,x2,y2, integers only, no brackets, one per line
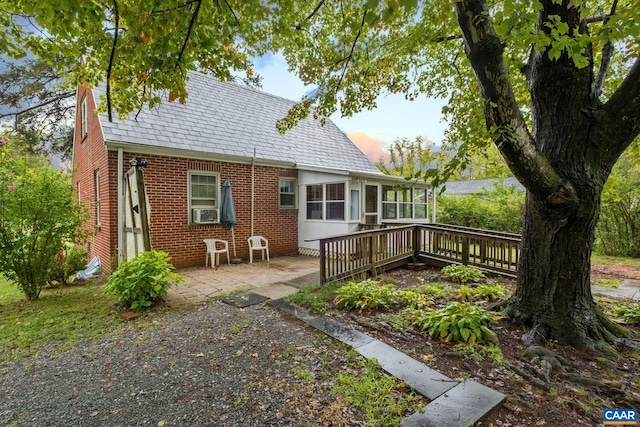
165,256,320,305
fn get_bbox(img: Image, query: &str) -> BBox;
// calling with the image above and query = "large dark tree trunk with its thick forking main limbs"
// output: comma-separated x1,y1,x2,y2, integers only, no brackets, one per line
454,0,640,348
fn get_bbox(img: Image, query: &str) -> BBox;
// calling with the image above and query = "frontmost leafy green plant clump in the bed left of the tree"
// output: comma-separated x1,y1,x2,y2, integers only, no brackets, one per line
410,302,494,343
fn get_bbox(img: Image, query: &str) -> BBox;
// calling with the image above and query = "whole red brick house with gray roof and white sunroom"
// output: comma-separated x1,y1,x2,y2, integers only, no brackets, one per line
73,73,433,272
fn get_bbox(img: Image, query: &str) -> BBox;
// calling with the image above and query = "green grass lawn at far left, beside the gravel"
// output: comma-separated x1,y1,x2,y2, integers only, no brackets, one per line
0,276,134,368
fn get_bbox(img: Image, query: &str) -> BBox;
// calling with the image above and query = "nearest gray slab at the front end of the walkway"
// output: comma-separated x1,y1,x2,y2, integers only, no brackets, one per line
401,380,504,427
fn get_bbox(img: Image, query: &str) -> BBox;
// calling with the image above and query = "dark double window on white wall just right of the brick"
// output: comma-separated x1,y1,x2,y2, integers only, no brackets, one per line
307,182,346,221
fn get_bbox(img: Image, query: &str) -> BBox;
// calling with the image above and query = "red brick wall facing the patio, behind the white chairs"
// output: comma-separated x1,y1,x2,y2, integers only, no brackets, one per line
109,152,298,268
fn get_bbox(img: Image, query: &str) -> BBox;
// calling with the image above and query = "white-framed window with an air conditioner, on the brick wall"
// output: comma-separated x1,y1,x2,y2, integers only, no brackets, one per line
188,171,220,224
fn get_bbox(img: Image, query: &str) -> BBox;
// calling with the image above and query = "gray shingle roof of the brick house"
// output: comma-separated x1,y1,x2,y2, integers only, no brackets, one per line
94,72,379,173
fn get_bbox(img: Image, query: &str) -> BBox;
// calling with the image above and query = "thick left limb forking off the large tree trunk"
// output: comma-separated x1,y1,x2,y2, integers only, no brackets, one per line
453,0,575,205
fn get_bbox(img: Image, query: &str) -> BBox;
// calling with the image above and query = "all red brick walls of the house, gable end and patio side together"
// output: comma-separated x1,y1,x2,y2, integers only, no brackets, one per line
73,87,298,274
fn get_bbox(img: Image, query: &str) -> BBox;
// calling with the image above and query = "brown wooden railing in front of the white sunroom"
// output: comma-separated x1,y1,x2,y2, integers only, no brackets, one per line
320,224,520,283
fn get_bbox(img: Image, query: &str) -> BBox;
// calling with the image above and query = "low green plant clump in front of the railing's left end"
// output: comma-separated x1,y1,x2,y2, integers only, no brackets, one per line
335,279,400,310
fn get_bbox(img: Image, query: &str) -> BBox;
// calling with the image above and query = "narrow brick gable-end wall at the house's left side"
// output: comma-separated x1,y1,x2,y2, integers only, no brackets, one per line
73,87,117,273
